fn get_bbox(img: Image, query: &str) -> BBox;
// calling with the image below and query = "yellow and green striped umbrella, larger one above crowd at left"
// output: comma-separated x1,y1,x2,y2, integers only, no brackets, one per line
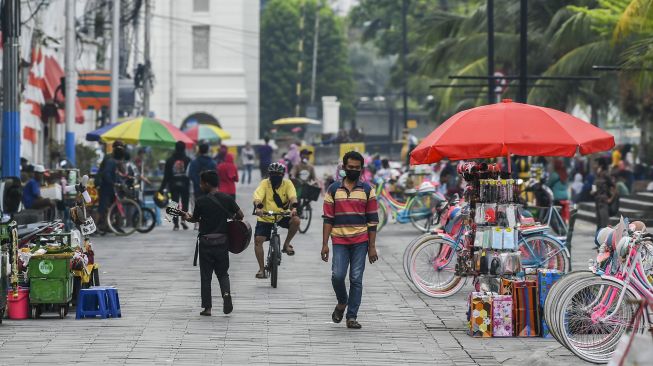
100,117,195,148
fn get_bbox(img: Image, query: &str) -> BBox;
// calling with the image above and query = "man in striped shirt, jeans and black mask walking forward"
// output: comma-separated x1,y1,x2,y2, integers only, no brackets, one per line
322,151,379,329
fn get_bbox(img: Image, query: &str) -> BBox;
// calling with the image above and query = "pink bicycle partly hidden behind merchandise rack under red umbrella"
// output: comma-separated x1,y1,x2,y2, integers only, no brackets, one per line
404,197,571,298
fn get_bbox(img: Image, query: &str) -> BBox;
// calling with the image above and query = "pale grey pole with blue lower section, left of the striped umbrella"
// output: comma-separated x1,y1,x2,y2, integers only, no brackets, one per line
64,0,77,166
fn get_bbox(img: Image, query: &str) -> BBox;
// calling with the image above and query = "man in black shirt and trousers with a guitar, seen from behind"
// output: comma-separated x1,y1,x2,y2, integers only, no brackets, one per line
185,170,244,316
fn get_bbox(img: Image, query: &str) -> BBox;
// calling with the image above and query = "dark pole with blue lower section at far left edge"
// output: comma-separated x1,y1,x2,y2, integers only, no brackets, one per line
1,0,20,177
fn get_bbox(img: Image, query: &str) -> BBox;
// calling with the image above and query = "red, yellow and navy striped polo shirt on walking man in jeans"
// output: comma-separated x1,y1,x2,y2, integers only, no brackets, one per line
322,181,379,244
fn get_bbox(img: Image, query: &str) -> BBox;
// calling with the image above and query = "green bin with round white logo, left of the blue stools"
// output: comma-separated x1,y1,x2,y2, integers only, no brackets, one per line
27,253,73,319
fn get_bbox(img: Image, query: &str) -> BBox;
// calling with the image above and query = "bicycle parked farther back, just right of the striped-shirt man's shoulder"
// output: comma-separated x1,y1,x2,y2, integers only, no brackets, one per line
376,179,446,233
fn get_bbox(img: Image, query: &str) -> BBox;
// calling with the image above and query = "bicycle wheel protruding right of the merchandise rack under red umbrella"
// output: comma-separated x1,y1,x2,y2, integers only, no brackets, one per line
519,234,571,273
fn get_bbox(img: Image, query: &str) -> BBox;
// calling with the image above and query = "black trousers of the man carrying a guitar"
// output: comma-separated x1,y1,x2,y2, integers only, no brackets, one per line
199,244,231,308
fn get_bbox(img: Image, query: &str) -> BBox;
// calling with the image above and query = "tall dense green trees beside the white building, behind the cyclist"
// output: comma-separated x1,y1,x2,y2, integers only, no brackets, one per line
260,0,353,135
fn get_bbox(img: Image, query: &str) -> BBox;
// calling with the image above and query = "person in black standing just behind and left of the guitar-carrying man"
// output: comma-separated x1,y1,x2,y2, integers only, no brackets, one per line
159,141,190,231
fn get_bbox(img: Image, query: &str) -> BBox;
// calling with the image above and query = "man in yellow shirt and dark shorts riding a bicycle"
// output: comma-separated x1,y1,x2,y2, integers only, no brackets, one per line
254,163,300,278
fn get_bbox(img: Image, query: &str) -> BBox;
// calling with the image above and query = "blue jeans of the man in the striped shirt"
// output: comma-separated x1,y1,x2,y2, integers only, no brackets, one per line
331,243,367,319
